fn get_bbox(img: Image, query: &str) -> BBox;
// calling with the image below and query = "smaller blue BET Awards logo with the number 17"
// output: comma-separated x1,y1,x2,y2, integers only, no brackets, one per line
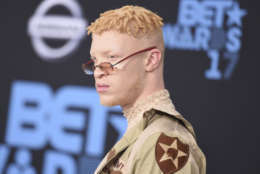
163,0,247,80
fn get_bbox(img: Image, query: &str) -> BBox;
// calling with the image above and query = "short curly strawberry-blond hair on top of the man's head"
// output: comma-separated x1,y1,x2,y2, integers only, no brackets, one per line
87,5,163,37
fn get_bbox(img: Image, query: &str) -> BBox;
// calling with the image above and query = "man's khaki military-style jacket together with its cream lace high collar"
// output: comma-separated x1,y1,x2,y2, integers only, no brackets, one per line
95,90,206,174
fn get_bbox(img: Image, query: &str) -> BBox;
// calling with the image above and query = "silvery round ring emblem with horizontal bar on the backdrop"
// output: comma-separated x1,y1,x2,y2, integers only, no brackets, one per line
28,0,87,60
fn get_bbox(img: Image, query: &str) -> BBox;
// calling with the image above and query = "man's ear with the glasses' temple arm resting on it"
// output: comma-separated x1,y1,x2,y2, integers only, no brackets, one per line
145,48,162,72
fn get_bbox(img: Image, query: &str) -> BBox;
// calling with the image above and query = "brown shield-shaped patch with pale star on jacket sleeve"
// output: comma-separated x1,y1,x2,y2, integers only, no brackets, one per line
155,133,189,174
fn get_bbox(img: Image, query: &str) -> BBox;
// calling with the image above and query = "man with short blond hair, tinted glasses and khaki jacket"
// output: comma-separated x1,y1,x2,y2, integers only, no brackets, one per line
83,6,206,174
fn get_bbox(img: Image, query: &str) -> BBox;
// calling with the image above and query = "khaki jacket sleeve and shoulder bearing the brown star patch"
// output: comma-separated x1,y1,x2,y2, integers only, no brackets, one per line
125,111,205,173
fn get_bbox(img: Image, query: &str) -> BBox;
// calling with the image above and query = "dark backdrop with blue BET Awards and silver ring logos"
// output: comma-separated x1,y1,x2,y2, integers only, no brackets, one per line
0,0,260,174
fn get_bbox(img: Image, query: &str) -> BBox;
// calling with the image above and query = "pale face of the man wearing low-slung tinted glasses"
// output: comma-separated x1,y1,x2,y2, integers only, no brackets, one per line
90,31,146,107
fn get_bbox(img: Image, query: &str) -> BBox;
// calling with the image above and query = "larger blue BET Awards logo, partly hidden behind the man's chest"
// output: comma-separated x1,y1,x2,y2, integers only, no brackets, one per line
0,81,127,174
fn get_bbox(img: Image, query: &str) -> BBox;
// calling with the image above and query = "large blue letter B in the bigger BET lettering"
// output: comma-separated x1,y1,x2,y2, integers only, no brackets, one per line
6,81,51,149
